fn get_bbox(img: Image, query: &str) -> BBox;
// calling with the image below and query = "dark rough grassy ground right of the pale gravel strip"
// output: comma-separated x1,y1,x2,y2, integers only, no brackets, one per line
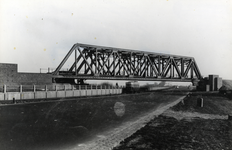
114,93,232,150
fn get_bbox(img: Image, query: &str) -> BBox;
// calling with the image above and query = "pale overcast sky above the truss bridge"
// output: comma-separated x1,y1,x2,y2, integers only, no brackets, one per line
0,0,232,79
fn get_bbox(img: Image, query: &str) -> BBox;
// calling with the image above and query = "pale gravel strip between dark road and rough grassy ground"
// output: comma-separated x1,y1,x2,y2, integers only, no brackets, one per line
72,96,185,150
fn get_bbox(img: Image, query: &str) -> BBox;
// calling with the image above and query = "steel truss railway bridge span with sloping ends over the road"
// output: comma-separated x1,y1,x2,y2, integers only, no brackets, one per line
53,43,202,83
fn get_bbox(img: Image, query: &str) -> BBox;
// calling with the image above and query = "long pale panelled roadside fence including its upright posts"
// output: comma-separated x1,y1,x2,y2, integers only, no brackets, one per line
0,85,122,100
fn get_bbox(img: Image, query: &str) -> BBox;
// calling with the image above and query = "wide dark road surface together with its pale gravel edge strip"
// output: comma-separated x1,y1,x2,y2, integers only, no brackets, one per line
0,91,185,150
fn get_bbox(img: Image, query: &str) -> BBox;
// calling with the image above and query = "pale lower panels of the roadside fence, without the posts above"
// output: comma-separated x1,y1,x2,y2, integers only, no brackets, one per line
0,89,122,100
